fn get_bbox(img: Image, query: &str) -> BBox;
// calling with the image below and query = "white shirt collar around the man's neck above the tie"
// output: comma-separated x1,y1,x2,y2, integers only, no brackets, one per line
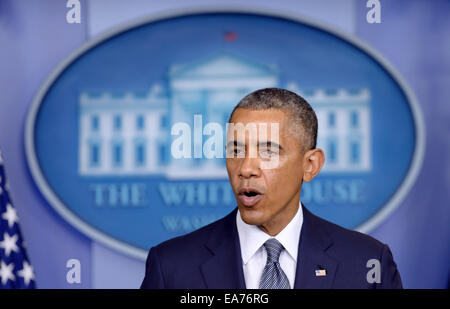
236,204,303,264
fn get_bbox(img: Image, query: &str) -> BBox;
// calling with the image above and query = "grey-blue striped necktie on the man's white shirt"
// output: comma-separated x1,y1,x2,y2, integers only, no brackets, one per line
259,238,291,289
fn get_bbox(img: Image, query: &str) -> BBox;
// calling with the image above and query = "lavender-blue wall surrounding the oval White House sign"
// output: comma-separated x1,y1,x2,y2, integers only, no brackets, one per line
0,1,450,288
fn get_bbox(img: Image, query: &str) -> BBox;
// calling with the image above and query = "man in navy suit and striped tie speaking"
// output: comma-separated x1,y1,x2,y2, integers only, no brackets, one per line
141,88,402,289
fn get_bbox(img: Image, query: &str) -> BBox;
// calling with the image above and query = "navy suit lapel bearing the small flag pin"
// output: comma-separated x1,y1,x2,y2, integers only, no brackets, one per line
294,205,338,289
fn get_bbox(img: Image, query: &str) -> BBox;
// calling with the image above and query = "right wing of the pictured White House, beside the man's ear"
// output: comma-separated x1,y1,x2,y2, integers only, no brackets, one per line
286,83,372,172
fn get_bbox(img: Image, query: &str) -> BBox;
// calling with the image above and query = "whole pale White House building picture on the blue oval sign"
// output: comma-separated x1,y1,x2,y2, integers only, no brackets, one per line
79,53,371,178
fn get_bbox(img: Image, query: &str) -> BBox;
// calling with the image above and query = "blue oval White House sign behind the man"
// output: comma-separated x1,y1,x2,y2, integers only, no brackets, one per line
26,9,424,258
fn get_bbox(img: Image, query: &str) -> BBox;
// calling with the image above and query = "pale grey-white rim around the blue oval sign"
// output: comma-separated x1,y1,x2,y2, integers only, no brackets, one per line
25,5,425,260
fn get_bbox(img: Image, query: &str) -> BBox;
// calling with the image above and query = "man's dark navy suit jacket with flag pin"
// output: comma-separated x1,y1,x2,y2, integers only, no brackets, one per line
141,206,402,289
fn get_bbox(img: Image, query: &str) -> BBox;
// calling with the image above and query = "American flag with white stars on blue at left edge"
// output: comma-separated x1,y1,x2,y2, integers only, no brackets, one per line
0,153,35,289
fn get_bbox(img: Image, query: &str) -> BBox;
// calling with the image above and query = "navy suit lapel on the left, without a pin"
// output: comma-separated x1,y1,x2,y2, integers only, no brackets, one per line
200,208,245,289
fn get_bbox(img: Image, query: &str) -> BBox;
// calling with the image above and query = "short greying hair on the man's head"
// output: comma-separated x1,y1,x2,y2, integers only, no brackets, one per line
229,88,318,150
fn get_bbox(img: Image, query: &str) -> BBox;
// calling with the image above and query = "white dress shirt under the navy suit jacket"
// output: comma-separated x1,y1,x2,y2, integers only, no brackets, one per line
236,205,303,289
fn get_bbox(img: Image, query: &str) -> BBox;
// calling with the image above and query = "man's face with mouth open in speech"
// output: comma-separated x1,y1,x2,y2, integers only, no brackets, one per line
227,108,303,230
